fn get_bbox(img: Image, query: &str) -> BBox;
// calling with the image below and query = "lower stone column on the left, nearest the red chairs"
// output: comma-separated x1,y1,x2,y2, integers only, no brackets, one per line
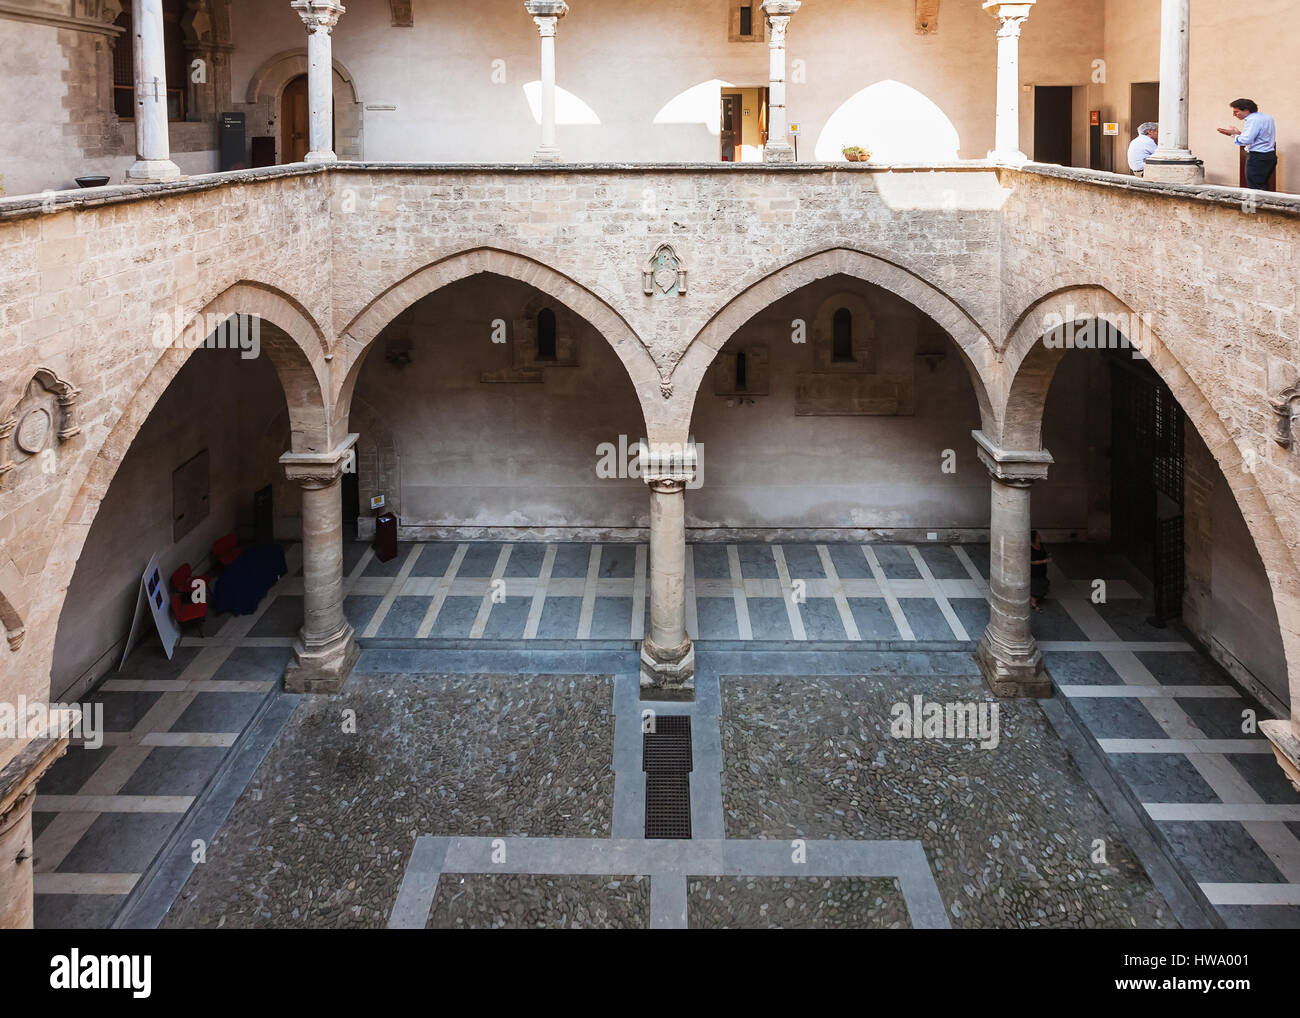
280,434,360,693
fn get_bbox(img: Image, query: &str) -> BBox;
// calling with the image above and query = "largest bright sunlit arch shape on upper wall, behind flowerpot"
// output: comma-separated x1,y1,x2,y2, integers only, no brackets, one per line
816,81,962,163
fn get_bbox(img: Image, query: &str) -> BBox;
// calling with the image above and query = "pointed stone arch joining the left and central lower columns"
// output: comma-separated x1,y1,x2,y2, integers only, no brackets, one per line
334,247,663,426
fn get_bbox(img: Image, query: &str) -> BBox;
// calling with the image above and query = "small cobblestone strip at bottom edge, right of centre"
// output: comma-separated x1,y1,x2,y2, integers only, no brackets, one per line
686,876,911,930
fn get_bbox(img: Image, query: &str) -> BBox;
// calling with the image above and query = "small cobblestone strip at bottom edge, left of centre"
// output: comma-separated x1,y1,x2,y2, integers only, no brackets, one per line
426,874,650,930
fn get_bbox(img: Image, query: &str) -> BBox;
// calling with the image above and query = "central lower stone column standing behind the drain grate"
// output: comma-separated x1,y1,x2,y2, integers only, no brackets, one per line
641,445,696,699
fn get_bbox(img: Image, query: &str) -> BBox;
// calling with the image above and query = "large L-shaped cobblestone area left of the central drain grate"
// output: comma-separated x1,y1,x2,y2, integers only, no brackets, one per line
165,675,614,927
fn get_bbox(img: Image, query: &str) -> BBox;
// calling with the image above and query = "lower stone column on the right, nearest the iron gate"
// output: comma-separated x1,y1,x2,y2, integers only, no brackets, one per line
974,432,1052,697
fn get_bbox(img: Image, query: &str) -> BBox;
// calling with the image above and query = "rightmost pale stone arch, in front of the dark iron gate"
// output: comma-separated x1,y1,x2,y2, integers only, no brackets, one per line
989,285,1300,716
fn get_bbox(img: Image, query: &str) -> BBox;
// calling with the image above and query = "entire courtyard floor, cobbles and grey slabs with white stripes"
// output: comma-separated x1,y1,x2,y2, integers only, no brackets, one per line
34,543,1300,928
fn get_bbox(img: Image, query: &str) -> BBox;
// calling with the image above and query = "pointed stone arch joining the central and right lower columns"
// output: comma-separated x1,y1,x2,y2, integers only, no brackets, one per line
659,247,996,442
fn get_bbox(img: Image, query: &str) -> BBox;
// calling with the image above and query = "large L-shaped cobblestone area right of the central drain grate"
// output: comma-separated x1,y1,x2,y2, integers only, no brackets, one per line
722,676,1177,928
